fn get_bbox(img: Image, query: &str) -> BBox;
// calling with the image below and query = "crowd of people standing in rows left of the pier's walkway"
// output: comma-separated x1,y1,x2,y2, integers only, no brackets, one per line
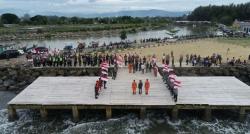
26,49,123,67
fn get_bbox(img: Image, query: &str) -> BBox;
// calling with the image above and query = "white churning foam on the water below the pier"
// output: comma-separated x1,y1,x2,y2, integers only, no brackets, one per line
0,109,250,134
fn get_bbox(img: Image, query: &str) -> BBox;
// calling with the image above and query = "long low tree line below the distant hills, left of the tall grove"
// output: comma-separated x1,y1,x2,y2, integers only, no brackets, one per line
0,13,169,25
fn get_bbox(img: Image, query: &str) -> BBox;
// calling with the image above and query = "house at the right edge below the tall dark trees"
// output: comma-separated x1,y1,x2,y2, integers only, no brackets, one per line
233,20,250,34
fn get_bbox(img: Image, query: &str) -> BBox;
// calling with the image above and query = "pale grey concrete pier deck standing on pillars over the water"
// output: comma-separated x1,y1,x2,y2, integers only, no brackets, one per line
8,69,250,121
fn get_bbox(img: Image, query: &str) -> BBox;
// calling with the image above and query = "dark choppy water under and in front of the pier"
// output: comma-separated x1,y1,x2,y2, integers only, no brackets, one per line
0,92,250,134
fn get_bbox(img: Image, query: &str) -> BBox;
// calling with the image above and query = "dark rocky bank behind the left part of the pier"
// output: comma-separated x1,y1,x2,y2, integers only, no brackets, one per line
0,67,113,93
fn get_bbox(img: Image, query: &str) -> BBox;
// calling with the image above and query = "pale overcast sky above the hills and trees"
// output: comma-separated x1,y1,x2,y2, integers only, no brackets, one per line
0,0,249,15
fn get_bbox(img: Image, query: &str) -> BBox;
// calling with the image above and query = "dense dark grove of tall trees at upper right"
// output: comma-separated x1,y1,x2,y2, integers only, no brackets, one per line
188,2,250,25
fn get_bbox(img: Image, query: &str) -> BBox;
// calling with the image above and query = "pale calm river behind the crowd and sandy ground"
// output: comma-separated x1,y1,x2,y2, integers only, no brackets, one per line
0,26,214,49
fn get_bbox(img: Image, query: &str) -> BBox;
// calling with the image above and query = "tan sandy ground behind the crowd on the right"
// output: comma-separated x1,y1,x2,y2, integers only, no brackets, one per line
120,39,250,62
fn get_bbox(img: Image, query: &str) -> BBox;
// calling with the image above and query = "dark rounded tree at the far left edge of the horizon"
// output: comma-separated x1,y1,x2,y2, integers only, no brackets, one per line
1,13,20,24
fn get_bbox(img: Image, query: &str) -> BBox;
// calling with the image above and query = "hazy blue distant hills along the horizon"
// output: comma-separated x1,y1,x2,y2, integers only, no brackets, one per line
0,9,189,18
